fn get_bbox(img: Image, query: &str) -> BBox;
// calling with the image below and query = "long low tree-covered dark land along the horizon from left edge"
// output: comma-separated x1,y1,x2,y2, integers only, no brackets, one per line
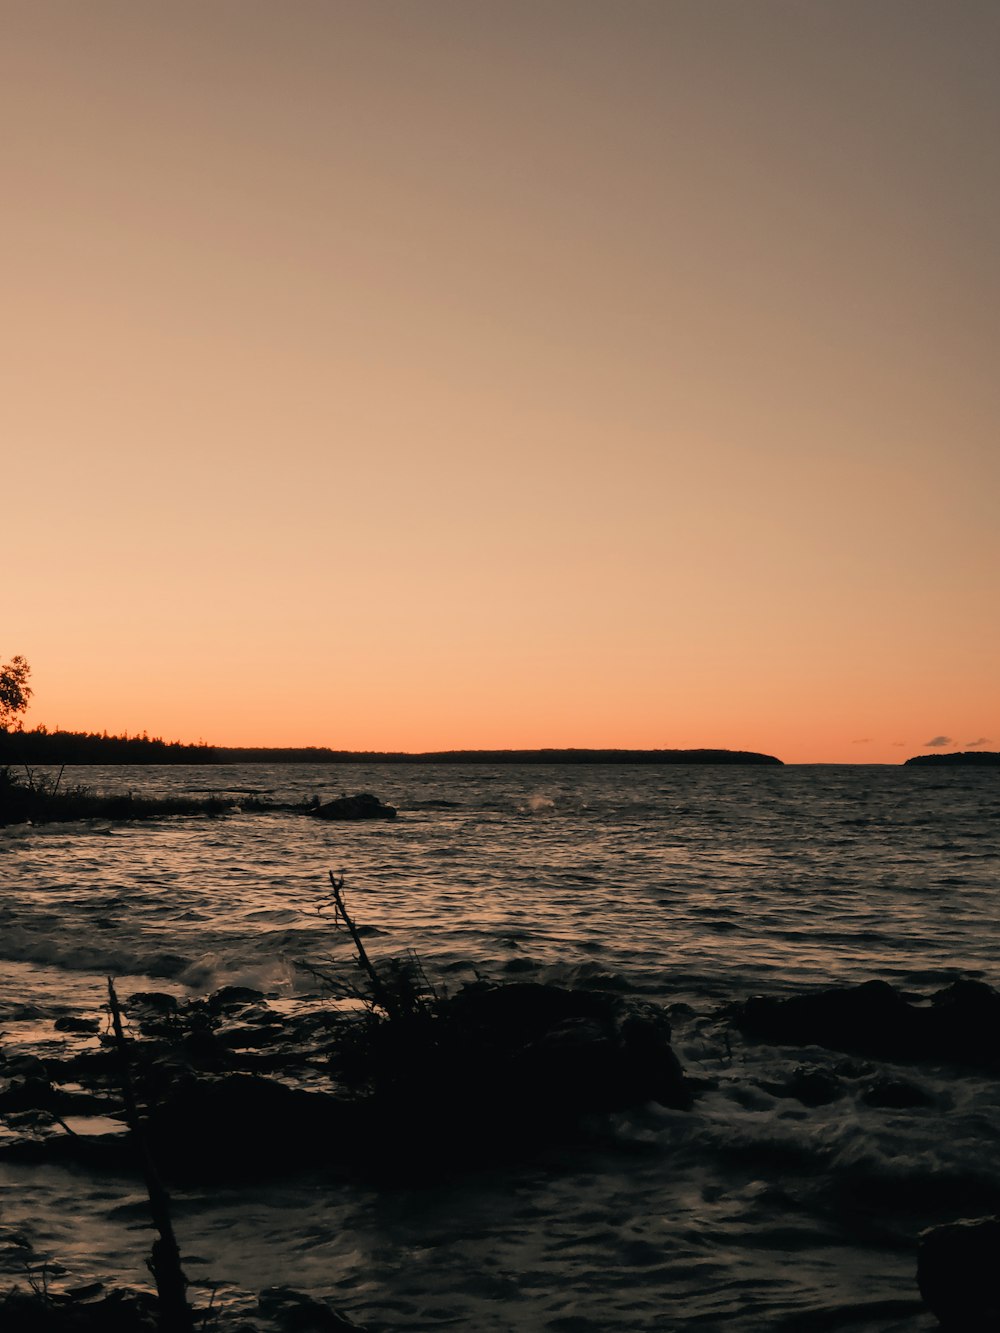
0,726,781,765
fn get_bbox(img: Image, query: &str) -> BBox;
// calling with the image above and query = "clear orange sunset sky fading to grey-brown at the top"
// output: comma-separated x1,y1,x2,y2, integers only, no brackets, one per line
0,0,1000,762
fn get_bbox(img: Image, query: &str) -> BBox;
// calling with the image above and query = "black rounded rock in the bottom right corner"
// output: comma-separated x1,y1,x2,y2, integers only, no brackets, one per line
917,1217,1000,1333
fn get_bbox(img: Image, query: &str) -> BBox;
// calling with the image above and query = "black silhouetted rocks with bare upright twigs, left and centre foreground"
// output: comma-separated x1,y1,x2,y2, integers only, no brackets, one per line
0,876,696,1333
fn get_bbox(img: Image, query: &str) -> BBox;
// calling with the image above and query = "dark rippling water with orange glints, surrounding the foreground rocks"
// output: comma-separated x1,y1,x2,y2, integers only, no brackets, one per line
0,765,1000,1333
